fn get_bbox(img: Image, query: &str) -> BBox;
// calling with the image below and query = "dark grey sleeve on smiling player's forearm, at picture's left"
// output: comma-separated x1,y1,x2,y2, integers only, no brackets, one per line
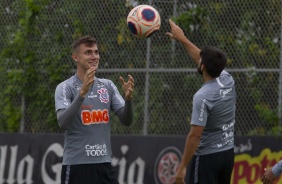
56,94,84,129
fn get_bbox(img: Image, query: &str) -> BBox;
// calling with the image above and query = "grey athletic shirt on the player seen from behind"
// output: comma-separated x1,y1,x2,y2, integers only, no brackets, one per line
191,70,236,155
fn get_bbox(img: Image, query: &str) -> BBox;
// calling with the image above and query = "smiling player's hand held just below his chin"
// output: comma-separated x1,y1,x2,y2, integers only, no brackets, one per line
79,67,97,98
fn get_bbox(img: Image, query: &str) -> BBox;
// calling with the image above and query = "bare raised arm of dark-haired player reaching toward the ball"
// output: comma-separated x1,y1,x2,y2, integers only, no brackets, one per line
166,19,201,66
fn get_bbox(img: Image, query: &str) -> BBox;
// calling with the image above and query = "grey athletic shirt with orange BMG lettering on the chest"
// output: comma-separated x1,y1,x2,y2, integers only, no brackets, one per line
55,75,125,165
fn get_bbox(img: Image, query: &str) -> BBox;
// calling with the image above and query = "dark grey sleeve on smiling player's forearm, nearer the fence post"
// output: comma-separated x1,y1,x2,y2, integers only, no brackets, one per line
116,100,134,126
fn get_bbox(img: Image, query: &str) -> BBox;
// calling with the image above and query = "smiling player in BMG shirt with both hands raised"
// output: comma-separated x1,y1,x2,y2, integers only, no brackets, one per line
55,35,134,184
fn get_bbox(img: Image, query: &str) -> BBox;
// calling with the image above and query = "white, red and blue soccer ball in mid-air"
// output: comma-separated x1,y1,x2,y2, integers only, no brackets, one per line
127,5,161,38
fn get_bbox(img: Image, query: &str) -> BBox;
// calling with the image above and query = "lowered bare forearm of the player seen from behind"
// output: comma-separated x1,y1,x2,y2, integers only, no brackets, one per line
179,134,201,169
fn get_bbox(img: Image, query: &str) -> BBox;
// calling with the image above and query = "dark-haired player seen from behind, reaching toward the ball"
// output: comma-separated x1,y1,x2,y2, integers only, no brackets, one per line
167,20,236,184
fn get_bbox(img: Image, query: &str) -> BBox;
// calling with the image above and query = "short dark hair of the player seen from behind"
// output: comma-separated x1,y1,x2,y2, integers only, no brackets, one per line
200,45,227,77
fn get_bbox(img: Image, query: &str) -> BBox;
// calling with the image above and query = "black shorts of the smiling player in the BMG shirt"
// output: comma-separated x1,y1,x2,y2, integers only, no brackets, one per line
61,163,119,184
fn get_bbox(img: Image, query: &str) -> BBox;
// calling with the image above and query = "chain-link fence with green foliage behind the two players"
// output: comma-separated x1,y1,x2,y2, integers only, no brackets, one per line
0,0,282,135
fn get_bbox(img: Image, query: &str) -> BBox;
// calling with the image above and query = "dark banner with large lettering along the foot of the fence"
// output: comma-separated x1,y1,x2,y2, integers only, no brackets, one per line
0,133,282,184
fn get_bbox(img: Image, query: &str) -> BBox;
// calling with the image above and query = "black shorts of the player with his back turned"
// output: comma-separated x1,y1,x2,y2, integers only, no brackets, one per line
185,149,235,184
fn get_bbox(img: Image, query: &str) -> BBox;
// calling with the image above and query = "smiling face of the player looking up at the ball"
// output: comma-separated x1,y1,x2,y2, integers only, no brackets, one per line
73,44,100,71
